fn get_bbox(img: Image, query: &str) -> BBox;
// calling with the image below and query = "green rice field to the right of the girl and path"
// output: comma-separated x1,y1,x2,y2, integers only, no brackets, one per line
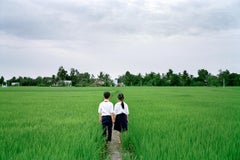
124,88,240,160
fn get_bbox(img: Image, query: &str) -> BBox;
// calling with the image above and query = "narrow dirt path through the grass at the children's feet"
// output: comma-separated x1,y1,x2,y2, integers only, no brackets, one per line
108,130,122,160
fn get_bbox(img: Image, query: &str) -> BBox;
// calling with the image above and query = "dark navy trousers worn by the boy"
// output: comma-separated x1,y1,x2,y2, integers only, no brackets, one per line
102,116,112,141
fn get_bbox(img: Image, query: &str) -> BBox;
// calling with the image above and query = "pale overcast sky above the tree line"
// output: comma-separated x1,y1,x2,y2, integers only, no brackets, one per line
0,0,240,80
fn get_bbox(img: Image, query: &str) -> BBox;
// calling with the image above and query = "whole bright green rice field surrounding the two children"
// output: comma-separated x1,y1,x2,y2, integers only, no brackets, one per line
0,87,240,160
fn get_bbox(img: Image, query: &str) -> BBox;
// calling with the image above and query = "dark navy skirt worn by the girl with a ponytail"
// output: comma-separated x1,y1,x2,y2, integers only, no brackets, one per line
114,113,128,132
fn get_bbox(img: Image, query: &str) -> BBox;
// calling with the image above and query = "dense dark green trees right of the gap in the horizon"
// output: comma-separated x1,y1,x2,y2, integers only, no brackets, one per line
118,69,240,86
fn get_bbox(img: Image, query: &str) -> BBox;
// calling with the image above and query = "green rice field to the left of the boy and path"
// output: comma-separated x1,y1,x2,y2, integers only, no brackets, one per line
0,88,106,159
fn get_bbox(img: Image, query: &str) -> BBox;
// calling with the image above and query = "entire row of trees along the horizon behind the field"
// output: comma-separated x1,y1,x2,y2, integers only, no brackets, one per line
0,66,240,87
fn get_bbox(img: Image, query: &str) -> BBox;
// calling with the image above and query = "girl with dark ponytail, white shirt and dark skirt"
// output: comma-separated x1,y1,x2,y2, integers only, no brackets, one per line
114,93,129,143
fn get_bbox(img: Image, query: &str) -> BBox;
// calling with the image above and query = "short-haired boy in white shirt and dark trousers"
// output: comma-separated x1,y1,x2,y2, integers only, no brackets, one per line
98,92,114,142
